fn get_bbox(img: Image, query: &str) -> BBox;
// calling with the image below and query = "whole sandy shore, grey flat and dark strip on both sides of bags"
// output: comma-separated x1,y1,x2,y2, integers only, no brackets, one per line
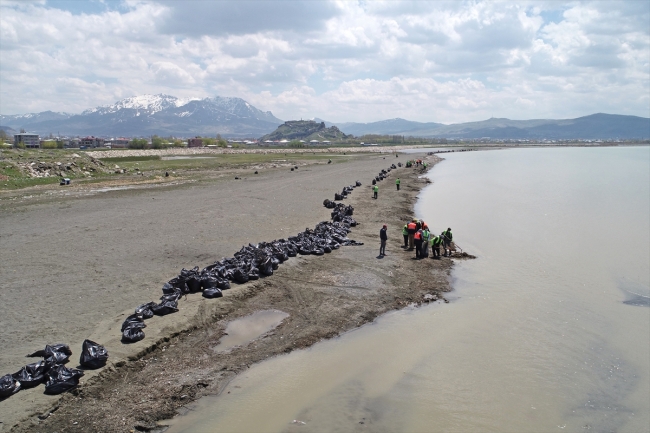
0,151,452,432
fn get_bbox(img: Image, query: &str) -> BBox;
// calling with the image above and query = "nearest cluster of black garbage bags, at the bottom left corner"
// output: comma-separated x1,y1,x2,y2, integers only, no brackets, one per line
0,340,108,400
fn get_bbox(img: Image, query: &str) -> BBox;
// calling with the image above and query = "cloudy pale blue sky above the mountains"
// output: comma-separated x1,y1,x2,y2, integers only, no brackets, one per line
0,0,650,123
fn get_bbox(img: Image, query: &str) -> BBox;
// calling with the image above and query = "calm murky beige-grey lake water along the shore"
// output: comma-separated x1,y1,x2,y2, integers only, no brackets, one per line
169,147,650,432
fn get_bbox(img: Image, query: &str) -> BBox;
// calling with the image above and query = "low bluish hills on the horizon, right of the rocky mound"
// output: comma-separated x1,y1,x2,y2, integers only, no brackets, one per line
325,113,650,140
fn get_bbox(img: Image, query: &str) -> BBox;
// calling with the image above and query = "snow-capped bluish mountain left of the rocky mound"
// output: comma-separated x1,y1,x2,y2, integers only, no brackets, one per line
0,94,282,137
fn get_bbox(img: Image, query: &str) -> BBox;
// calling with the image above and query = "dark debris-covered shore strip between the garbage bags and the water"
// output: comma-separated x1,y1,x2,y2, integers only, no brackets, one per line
5,152,464,432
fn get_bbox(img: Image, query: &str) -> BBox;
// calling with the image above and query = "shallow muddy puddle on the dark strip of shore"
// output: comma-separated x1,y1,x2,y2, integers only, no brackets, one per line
212,310,289,352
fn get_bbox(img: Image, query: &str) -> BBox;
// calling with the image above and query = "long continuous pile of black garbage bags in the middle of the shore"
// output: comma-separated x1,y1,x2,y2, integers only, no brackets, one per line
121,181,363,343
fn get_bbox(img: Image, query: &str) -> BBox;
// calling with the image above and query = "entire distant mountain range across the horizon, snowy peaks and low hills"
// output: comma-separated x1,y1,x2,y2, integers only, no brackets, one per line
0,94,650,140
